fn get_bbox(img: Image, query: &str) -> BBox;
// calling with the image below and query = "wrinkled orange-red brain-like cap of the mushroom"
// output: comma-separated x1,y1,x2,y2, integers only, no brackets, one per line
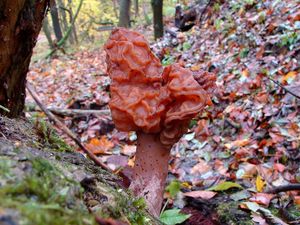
105,28,212,146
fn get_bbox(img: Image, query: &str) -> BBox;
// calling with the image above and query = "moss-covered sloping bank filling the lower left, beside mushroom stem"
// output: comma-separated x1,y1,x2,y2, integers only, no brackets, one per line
0,117,156,225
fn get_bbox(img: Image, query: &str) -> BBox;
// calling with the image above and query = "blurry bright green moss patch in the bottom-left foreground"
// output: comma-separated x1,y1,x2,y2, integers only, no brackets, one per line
0,158,95,225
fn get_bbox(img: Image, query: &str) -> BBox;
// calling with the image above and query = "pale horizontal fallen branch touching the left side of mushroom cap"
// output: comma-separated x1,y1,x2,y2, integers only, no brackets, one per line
47,108,110,116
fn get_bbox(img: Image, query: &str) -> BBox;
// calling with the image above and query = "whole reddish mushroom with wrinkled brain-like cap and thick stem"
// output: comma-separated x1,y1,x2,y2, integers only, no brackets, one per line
105,28,215,216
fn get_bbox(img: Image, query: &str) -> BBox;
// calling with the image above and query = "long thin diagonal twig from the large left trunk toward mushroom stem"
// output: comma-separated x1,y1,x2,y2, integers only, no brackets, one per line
26,82,112,172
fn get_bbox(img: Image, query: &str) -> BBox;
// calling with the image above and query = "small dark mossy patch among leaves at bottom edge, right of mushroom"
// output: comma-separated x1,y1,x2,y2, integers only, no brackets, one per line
217,202,254,225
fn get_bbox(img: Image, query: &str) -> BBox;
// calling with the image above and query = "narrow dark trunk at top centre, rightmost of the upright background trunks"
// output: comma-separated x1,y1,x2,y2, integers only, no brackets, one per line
151,0,164,39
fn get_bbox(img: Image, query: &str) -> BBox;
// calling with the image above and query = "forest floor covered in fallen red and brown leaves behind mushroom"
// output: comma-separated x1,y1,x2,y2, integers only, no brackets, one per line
27,0,300,225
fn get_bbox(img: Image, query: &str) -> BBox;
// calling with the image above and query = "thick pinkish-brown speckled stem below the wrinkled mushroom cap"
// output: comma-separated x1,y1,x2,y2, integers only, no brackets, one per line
129,132,170,216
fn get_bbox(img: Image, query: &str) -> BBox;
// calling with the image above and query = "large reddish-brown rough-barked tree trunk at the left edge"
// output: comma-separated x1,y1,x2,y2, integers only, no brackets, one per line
0,0,49,117
